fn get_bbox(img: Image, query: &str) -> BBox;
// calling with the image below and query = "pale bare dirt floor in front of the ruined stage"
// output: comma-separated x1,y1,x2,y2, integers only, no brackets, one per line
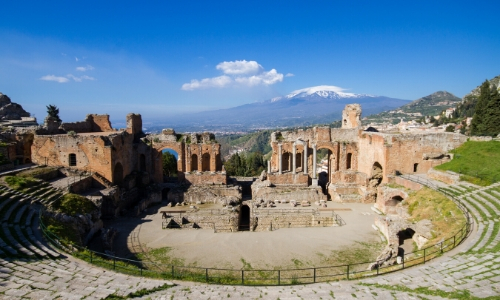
106,202,381,268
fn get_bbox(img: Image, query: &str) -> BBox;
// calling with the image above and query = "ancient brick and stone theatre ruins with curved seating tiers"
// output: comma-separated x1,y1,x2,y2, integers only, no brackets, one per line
0,104,500,299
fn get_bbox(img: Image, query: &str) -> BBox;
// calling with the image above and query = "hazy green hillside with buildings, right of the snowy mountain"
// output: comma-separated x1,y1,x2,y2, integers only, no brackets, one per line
363,91,462,123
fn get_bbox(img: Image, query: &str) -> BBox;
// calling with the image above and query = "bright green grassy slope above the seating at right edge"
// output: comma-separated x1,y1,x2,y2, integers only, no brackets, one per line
435,141,500,186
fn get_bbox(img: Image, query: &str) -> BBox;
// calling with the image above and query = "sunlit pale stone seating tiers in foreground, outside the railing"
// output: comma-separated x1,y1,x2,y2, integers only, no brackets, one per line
0,176,500,299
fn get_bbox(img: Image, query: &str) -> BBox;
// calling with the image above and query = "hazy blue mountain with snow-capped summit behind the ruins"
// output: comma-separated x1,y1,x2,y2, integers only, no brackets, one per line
164,85,409,130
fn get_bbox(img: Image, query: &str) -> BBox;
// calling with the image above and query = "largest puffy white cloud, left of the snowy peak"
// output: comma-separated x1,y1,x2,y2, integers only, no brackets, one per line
181,60,286,91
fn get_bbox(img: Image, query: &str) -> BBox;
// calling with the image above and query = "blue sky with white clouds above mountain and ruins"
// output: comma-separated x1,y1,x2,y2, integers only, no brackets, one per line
0,0,500,122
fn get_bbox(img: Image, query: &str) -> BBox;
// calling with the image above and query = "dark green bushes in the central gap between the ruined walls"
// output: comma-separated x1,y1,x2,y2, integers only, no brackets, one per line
224,152,266,176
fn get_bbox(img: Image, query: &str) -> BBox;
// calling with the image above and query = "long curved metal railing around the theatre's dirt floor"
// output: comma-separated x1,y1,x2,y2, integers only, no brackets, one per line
39,178,472,285
